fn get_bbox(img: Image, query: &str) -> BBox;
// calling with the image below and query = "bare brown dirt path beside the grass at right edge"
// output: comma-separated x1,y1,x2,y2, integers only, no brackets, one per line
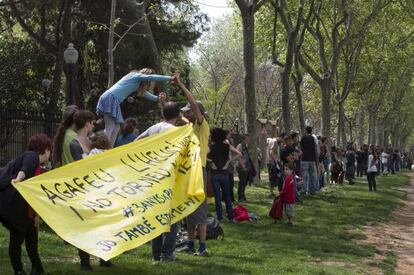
362,174,414,275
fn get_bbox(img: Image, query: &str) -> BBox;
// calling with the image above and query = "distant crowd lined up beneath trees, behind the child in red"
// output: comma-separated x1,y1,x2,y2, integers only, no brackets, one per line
268,129,414,200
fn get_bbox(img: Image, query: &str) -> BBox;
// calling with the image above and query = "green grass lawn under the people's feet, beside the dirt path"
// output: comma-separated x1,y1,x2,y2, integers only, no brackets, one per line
0,175,409,275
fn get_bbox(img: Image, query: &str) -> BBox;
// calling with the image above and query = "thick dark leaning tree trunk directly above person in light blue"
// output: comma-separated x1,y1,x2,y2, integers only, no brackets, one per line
120,0,161,73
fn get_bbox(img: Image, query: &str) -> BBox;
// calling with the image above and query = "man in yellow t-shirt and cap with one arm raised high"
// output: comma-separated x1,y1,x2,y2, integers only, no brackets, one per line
174,75,210,256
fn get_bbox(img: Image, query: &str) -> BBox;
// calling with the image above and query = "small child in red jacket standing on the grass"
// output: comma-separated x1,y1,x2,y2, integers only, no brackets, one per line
279,163,296,225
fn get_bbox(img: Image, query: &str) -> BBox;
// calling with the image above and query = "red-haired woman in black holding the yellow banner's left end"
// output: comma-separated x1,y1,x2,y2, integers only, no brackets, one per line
0,134,52,275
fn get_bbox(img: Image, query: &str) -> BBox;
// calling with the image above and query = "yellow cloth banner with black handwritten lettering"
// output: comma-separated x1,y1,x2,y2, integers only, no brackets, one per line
14,125,205,260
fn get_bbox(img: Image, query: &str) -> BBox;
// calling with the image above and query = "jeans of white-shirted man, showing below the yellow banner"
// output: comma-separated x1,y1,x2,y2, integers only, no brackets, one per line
151,223,178,261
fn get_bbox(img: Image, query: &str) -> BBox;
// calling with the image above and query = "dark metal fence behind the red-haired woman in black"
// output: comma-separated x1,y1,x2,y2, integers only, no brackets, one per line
0,107,61,166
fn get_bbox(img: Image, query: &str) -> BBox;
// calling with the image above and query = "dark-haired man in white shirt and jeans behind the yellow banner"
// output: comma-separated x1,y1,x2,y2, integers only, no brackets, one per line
136,101,180,263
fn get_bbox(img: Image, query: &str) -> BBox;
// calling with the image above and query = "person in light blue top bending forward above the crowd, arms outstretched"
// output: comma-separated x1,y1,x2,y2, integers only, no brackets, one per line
96,68,174,145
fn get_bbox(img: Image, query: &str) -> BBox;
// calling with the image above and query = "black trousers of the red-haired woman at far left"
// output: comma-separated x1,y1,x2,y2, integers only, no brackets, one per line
9,224,43,273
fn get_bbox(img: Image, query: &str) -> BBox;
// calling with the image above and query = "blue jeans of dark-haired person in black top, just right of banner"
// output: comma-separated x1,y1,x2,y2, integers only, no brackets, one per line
211,172,233,221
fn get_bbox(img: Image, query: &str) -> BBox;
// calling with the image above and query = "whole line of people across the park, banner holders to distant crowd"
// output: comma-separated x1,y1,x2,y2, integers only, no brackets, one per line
0,69,412,275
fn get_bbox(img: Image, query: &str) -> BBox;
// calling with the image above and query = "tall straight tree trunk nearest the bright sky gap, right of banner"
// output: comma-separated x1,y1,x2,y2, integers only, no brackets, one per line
242,9,260,181
